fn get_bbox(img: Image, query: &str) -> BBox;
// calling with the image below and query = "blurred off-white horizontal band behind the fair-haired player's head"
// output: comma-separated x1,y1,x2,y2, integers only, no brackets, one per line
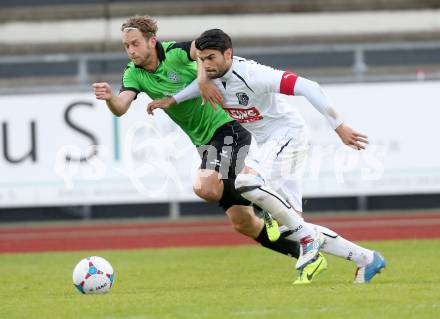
0,9,440,44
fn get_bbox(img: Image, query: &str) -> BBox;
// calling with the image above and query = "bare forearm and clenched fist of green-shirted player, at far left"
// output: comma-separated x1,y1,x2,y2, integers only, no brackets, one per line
92,82,136,116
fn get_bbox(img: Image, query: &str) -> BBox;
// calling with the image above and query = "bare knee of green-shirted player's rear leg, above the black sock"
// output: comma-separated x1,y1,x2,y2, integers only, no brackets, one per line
226,205,264,238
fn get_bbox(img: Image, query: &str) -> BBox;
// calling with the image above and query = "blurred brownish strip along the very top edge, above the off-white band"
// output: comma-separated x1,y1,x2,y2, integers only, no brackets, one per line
0,0,440,21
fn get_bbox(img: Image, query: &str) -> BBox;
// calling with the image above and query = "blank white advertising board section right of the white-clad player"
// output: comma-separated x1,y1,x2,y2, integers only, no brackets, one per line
301,82,440,196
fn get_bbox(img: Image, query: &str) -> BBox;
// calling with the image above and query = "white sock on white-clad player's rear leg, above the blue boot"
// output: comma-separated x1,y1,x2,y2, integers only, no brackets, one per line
309,224,374,267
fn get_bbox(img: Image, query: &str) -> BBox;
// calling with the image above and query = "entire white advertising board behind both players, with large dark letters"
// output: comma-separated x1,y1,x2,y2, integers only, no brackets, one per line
0,82,440,207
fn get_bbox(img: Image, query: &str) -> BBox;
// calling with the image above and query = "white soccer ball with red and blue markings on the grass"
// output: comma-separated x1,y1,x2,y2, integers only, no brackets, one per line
72,256,114,294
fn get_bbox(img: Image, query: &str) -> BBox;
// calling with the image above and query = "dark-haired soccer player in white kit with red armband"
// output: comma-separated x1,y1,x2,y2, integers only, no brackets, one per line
149,29,385,283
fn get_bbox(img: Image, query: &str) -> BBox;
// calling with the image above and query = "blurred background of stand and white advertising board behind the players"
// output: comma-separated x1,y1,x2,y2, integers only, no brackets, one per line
0,0,440,222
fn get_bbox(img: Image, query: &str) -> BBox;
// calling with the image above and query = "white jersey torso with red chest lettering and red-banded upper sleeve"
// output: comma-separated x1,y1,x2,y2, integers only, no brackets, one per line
214,56,305,144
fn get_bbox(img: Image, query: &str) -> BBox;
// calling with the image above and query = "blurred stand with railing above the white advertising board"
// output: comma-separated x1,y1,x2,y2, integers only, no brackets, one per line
0,0,440,92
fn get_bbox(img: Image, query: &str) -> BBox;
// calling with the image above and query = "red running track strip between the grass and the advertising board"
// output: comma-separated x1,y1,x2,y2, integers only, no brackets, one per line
0,212,440,253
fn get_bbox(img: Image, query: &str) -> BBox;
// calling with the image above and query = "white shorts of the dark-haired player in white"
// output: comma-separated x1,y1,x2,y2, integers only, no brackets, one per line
245,128,309,212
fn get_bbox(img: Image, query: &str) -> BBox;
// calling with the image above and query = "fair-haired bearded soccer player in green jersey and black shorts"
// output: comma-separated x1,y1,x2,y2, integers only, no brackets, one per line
93,16,306,257
